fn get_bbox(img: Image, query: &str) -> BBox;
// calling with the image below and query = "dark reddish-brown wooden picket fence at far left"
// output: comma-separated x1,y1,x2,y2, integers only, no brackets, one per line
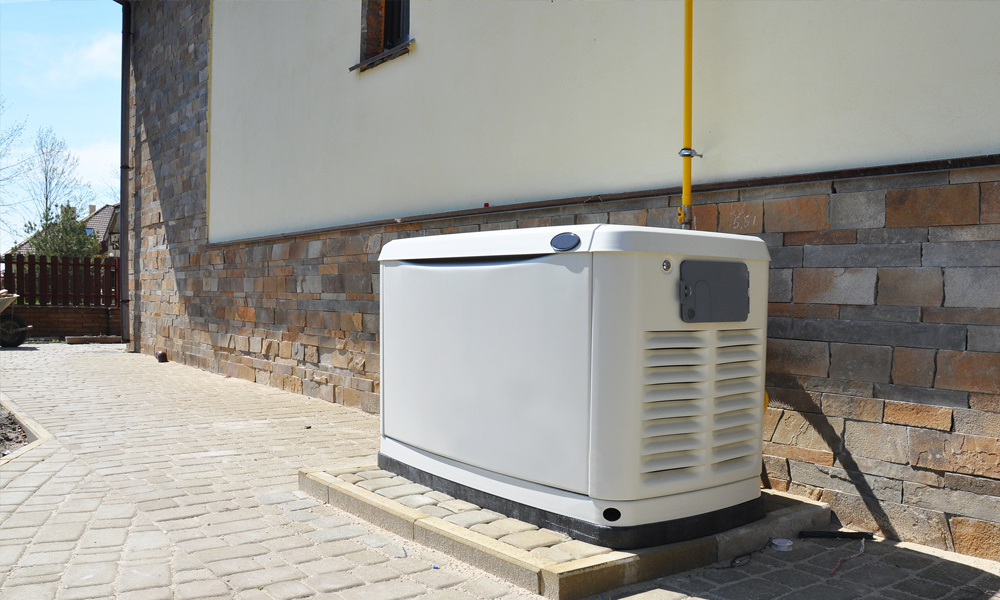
3,254,118,306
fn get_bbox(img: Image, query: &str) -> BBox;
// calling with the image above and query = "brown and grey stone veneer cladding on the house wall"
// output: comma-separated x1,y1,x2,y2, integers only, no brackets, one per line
130,2,1000,559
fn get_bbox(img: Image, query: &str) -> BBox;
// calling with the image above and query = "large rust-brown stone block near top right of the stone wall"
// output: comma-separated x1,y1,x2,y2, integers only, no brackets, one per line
885,183,979,227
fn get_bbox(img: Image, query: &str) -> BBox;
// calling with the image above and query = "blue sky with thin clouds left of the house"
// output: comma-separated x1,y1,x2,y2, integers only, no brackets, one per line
0,0,121,251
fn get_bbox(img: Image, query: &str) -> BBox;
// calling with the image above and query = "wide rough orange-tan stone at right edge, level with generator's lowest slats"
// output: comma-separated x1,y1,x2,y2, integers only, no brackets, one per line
909,429,1000,479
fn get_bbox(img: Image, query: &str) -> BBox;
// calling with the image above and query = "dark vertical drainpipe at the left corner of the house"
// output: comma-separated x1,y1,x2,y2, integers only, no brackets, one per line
118,0,132,343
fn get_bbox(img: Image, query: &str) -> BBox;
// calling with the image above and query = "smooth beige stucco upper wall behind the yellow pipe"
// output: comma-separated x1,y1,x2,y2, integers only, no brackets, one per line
209,0,1000,242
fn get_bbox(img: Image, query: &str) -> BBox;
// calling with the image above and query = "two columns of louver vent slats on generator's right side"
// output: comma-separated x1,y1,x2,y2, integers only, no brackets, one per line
640,329,763,481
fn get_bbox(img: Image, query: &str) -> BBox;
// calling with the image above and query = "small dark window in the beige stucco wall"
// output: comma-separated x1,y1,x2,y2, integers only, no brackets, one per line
349,0,413,71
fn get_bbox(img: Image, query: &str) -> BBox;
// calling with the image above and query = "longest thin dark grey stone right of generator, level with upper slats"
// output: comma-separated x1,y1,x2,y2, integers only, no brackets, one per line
767,316,968,350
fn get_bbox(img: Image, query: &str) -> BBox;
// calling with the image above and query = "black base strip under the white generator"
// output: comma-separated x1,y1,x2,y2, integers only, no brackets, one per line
378,452,767,550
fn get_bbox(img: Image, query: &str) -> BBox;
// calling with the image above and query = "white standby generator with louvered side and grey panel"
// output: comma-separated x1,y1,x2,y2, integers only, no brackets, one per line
379,225,769,547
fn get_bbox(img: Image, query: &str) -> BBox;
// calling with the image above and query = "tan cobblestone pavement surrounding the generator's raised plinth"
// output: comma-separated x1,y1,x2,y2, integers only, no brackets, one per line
0,344,1000,600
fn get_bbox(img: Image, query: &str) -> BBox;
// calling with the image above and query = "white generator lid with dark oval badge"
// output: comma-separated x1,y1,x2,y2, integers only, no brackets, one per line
379,224,770,261
